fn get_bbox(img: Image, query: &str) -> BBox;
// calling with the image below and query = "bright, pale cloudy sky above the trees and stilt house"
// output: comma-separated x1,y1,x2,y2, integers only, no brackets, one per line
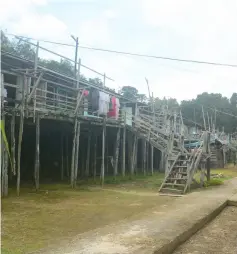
0,0,237,101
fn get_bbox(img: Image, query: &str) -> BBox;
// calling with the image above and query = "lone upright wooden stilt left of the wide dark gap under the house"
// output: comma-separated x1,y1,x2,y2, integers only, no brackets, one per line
34,114,40,190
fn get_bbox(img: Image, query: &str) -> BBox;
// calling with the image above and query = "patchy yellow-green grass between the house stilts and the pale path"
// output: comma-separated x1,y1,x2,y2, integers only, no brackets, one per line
2,174,168,254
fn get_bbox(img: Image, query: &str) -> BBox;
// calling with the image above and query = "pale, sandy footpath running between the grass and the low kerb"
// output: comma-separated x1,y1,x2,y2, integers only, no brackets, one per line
33,178,237,254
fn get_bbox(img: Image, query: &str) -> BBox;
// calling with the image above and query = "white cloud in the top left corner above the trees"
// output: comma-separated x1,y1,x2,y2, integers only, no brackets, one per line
0,0,67,39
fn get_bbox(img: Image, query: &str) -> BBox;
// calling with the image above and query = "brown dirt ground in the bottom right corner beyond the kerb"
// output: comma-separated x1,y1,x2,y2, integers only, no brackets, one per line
174,206,237,254
